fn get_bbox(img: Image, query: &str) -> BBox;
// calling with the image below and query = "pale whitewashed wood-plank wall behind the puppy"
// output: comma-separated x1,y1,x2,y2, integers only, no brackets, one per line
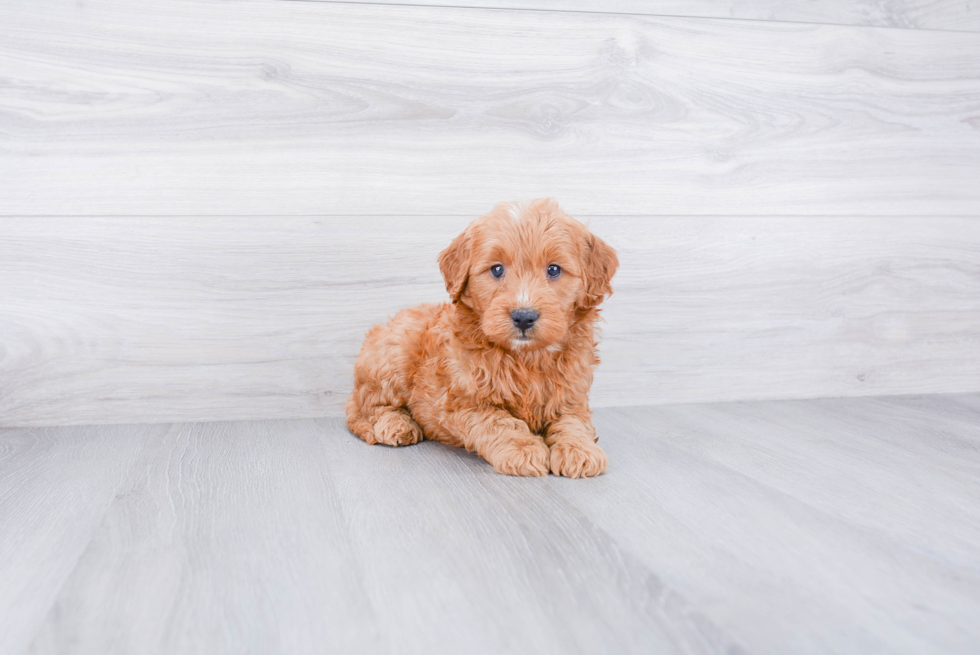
0,0,980,425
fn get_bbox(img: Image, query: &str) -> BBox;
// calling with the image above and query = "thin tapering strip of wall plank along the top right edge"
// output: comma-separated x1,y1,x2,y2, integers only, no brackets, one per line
298,0,980,32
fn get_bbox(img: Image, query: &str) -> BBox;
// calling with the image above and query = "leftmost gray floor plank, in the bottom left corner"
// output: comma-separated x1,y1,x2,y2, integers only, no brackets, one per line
0,426,159,653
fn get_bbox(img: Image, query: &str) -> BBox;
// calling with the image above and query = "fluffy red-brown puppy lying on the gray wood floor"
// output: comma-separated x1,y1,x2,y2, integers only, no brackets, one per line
345,199,619,478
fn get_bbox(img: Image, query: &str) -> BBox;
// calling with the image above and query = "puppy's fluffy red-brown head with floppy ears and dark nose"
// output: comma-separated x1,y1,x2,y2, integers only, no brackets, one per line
439,199,619,350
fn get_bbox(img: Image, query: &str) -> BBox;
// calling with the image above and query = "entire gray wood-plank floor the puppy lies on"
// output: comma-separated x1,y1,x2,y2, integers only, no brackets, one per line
0,395,980,654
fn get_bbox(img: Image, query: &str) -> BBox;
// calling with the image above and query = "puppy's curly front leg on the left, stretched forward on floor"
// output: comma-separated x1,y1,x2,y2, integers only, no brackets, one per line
442,407,549,476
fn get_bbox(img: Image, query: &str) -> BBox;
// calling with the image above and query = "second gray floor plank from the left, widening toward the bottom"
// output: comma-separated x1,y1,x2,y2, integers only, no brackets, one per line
27,422,386,653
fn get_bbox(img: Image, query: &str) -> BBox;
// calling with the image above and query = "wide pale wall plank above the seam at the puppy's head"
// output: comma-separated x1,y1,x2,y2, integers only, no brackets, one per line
0,0,980,216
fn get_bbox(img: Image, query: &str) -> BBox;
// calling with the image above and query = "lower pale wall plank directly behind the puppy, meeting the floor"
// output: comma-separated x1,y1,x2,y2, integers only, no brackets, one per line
0,217,980,425
